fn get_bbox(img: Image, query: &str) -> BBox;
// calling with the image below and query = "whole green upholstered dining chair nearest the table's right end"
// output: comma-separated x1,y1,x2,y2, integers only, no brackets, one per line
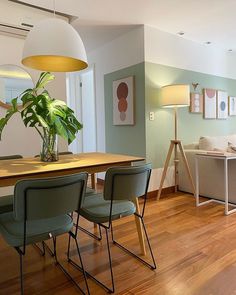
68,164,156,293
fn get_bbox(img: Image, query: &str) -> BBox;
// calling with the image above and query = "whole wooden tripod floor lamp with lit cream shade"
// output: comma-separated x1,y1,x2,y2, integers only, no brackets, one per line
157,84,195,200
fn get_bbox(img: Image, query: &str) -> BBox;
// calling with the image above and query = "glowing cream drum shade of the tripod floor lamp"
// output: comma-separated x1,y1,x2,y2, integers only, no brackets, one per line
161,84,190,107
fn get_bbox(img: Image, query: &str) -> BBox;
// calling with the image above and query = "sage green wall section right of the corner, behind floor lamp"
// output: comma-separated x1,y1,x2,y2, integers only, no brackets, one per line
145,62,236,168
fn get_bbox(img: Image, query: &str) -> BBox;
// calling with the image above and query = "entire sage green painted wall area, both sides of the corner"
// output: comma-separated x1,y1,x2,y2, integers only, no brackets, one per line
104,62,236,168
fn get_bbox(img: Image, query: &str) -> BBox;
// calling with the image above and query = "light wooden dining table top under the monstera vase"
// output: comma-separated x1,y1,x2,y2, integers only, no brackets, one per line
0,152,144,182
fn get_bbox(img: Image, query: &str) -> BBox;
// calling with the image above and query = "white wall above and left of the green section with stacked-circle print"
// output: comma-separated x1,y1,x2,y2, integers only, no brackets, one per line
88,26,144,152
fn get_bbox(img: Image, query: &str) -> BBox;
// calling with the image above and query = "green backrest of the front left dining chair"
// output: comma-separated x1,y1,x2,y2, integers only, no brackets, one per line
13,172,88,221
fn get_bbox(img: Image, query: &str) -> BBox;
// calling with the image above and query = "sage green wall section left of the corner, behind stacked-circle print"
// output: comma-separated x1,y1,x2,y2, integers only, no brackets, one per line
104,63,146,157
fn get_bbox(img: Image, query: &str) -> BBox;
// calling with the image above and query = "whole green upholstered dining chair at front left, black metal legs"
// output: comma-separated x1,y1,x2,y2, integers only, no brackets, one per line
0,173,89,294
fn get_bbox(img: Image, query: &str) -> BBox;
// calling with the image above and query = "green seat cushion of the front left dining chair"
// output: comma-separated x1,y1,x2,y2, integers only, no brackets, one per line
0,212,73,247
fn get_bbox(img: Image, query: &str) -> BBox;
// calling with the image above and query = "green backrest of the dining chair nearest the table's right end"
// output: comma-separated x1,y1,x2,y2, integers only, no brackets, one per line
104,164,151,200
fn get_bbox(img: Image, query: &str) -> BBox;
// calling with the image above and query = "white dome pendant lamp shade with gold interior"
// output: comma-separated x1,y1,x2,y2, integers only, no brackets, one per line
22,18,88,72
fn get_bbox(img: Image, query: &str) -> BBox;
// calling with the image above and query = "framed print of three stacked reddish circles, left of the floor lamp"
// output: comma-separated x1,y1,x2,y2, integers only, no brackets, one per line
113,76,134,125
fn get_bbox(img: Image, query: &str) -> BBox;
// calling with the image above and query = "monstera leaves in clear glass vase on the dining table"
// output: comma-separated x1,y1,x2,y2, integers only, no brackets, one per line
0,72,82,162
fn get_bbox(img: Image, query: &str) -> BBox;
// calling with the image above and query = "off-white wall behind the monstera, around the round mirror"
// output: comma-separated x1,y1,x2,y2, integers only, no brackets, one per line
0,35,67,156
